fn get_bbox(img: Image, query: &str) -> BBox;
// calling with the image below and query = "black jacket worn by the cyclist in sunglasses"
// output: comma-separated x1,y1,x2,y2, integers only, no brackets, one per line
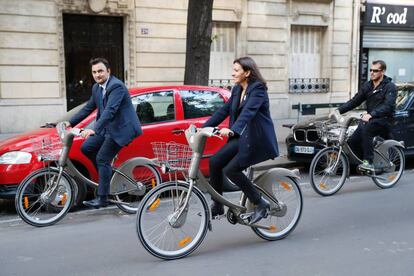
338,76,397,119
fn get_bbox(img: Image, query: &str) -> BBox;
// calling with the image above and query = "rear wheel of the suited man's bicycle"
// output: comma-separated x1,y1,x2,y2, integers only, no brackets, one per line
114,165,161,214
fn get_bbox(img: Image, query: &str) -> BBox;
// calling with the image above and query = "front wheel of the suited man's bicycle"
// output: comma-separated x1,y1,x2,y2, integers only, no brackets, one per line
15,168,74,227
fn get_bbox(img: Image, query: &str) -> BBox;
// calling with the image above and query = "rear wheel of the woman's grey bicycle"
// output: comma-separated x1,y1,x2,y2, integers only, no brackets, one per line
252,177,303,241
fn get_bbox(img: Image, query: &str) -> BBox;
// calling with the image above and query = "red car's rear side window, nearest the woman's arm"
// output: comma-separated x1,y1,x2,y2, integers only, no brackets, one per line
180,90,224,119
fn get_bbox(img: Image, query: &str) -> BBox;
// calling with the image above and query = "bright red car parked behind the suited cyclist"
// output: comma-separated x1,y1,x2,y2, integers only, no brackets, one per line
0,86,230,203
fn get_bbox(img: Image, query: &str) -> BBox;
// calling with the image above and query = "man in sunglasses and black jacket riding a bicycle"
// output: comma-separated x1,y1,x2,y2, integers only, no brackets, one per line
330,60,397,172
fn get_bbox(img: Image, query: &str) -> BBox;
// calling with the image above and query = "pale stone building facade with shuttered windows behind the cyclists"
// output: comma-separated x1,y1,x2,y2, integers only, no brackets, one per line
0,0,361,133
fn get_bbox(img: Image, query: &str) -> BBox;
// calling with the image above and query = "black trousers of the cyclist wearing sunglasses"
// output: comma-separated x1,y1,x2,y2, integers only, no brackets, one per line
348,118,392,163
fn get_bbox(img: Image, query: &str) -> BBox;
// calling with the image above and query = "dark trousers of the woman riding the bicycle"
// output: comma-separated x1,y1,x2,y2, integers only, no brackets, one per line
210,138,261,204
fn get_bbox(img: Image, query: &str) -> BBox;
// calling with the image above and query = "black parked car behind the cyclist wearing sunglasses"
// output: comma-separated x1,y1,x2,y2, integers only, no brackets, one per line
286,83,414,163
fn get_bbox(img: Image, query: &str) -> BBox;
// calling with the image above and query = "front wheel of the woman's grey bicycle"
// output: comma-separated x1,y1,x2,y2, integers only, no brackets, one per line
136,181,210,260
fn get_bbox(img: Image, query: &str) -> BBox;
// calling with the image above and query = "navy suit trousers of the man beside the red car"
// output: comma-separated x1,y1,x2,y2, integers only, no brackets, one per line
81,134,122,196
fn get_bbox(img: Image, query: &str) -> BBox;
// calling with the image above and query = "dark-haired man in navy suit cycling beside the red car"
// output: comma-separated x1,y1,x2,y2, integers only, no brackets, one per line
66,58,142,208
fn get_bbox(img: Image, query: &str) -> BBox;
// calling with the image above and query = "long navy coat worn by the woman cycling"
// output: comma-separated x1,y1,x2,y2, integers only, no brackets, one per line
204,82,279,167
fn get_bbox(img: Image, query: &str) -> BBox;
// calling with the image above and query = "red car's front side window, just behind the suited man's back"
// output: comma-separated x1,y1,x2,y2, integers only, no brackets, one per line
131,91,175,125
